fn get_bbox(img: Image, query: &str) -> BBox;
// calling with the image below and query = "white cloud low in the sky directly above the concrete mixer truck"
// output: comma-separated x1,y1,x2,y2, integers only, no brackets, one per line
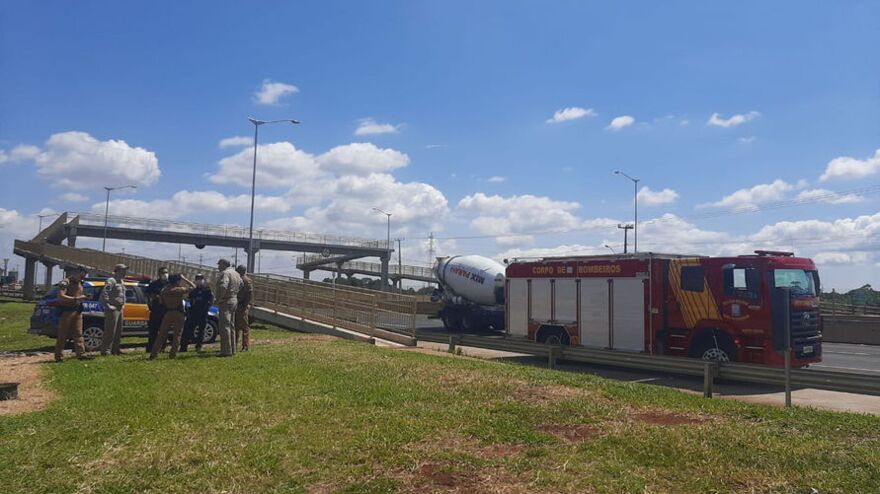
457,192,581,244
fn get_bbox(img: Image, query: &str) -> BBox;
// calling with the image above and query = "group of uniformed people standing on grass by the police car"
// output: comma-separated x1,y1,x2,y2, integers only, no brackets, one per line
55,259,253,362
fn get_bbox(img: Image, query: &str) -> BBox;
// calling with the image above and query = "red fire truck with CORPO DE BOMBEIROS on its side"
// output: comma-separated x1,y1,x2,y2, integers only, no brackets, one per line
505,251,822,366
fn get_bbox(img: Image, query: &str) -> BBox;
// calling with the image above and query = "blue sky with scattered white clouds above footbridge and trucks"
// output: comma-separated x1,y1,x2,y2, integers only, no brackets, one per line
0,1,880,289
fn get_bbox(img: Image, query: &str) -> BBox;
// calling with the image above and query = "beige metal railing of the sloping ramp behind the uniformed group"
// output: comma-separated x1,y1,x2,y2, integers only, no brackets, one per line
15,240,417,335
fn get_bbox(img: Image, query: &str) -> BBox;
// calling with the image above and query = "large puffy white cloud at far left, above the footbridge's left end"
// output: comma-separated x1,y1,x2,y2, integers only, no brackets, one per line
12,131,160,190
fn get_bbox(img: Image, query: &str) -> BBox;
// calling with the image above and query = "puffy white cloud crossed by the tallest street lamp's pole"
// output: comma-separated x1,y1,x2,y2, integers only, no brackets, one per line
210,142,321,187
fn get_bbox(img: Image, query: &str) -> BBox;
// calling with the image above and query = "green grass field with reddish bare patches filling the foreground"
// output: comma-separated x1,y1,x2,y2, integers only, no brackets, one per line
0,304,880,493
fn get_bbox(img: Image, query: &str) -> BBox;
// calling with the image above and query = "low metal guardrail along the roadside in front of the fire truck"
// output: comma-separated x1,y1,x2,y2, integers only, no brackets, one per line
416,331,880,396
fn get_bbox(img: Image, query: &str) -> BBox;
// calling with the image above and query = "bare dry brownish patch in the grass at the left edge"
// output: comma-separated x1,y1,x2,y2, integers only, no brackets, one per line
0,354,55,415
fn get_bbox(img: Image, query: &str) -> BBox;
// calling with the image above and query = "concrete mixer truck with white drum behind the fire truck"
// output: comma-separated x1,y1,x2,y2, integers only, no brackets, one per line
431,256,505,331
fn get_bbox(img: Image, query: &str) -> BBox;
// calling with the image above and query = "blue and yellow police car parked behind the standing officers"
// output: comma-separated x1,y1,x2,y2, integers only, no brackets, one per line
28,278,219,352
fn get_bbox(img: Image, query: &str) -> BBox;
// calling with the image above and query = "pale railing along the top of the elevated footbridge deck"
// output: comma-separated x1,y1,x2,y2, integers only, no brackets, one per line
74,212,389,250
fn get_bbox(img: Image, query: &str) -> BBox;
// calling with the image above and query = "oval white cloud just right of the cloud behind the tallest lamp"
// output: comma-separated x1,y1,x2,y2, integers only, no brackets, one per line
318,142,409,175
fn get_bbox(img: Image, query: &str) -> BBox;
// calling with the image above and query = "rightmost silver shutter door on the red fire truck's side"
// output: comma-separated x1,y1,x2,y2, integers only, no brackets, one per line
612,278,645,352
